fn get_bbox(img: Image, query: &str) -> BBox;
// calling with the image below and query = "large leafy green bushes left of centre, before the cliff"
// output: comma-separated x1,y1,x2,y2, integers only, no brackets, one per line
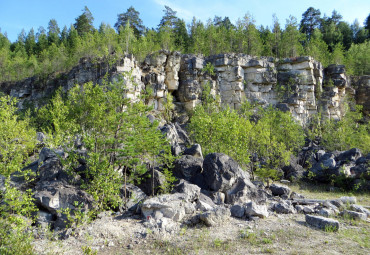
39,74,172,210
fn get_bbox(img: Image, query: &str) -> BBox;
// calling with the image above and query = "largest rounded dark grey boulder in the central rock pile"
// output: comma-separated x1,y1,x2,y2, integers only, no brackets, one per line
202,153,253,192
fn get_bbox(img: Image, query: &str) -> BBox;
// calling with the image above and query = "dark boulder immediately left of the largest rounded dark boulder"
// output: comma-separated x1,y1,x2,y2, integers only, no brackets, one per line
173,155,203,183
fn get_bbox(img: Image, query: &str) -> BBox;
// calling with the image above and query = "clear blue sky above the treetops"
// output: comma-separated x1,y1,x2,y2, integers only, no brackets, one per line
0,0,370,41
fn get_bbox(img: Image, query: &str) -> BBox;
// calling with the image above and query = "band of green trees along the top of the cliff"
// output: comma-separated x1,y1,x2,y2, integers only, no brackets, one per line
0,6,370,82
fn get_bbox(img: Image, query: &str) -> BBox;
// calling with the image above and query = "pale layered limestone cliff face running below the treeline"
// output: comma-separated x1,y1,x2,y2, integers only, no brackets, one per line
0,51,370,124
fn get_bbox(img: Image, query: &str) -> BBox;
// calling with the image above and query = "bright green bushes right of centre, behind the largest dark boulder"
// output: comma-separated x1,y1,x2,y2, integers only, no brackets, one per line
189,84,304,180
